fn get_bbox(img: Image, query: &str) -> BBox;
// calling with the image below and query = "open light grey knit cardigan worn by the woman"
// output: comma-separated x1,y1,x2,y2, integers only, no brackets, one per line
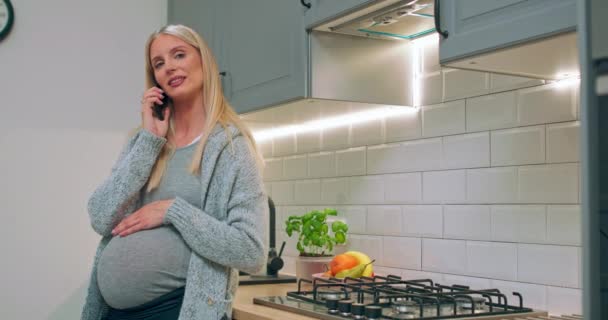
81,124,268,320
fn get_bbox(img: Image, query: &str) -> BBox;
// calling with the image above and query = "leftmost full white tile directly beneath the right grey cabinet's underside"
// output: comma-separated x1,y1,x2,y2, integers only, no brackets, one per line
443,69,490,101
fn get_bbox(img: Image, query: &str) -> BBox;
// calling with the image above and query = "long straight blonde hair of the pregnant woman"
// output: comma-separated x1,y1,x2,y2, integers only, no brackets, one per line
146,25,264,192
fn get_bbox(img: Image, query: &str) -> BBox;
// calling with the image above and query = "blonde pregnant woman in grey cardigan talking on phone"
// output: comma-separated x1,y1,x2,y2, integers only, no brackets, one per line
82,25,268,320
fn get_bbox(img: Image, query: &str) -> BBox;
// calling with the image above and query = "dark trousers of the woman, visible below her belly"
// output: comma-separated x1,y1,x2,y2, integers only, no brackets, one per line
104,287,185,320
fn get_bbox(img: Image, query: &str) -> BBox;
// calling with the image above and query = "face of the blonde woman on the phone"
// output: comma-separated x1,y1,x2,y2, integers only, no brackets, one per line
150,34,203,100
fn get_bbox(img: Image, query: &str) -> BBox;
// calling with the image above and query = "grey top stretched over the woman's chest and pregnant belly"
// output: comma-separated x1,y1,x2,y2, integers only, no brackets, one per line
97,140,202,309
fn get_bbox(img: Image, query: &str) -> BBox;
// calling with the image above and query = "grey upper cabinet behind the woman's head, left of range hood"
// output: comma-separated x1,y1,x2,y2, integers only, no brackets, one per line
169,0,307,113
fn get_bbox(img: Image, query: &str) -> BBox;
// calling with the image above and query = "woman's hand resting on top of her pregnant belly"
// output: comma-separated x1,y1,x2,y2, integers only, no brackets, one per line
112,199,174,237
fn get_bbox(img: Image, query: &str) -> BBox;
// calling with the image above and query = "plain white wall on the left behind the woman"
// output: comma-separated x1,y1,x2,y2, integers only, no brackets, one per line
0,0,167,320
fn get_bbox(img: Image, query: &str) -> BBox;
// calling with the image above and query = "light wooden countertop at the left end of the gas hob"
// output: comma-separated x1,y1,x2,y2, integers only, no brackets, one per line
232,283,315,320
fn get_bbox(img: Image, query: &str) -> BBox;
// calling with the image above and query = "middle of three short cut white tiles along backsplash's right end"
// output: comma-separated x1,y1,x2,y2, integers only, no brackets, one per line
547,205,582,246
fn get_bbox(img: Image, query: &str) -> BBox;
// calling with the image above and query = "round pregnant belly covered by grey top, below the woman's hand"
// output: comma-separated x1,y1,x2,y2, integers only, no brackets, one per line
97,226,191,309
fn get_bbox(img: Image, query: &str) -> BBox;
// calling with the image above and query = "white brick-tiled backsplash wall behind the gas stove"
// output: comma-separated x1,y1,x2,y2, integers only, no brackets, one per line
262,38,581,314
